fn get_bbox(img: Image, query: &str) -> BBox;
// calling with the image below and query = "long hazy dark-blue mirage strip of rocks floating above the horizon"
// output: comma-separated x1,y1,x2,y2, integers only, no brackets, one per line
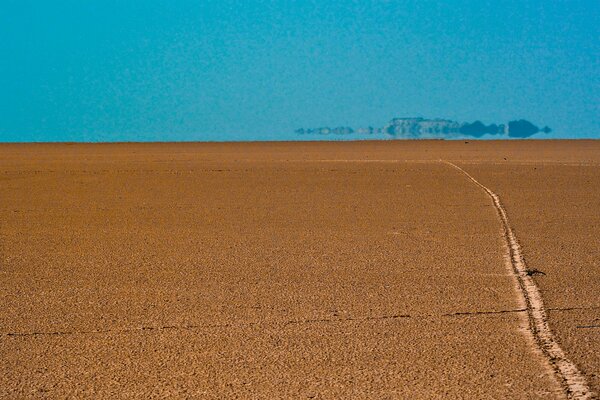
296,117,551,139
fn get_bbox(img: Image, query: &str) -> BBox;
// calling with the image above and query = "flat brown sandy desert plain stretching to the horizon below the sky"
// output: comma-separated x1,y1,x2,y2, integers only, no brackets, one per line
0,141,600,399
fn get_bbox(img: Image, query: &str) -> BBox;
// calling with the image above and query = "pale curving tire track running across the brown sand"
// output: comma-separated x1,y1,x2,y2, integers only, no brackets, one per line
440,160,596,399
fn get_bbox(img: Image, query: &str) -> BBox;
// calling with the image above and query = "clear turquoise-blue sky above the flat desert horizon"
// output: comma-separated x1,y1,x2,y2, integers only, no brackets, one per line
0,0,600,142
